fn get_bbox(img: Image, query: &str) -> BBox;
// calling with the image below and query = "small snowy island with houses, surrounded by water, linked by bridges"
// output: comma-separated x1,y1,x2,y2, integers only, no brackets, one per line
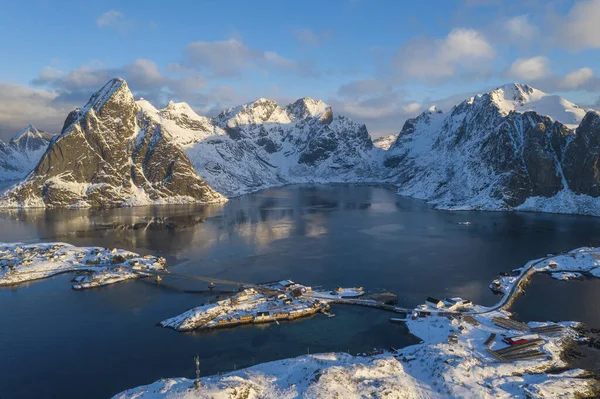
160,280,366,331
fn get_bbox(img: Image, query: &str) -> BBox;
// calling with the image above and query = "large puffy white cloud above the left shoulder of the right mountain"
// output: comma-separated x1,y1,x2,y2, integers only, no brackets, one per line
392,28,495,80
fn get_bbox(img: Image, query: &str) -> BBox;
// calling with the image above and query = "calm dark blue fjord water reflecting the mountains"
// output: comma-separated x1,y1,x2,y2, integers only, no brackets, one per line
0,185,600,398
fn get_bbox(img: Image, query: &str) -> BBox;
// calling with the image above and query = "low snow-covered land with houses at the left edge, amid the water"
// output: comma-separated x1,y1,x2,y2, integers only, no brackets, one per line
0,242,165,289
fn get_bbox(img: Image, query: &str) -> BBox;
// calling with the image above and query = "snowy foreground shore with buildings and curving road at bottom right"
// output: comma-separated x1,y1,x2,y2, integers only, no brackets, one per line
114,248,600,399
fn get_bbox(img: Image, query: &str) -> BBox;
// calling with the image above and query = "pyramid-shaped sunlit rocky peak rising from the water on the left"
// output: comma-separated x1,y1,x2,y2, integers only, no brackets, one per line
2,79,223,207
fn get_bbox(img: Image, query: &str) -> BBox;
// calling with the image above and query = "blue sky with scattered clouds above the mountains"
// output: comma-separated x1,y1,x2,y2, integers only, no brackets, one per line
0,0,600,140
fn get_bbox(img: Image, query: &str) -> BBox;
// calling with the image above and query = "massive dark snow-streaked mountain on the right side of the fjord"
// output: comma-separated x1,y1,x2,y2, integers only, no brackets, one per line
384,84,600,214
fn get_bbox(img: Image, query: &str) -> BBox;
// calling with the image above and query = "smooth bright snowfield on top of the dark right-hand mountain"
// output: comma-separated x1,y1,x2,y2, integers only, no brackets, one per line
490,83,585,129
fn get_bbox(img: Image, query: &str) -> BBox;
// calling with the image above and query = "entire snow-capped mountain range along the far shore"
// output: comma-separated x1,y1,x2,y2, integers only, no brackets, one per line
0,79,600,215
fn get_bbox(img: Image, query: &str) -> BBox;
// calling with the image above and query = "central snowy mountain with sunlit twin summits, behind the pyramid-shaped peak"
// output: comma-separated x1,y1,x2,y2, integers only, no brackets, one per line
179,98,382,196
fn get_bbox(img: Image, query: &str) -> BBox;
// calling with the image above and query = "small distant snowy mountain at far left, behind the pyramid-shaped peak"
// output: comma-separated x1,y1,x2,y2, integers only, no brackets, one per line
0,125,54,181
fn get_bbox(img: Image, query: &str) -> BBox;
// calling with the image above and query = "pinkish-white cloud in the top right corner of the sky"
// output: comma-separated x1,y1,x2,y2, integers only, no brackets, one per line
554,0,600,50
